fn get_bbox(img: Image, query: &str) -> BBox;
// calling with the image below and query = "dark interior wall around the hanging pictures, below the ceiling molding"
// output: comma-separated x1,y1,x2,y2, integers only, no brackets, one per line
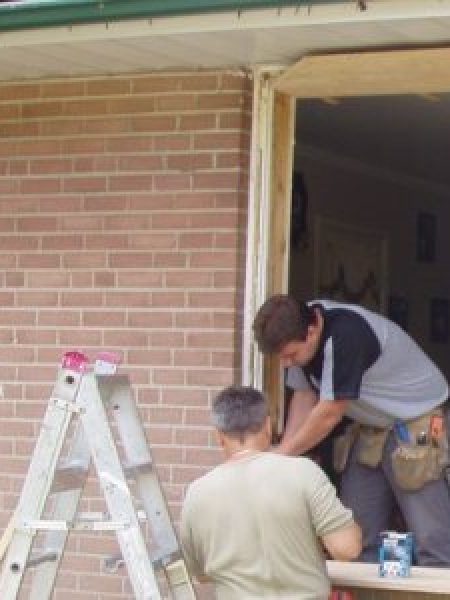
290,144,450,377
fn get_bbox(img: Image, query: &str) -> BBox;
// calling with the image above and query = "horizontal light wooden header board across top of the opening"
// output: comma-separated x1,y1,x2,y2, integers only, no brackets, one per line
274,48,450,98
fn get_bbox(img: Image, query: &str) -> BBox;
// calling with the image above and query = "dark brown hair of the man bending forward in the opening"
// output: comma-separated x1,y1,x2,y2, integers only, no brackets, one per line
253,294,316,354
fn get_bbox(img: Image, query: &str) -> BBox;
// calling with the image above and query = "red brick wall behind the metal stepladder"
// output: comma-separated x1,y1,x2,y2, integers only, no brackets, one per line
0,72,251,600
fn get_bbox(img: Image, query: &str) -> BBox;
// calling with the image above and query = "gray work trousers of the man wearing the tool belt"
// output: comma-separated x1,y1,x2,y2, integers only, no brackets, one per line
340,414,450,567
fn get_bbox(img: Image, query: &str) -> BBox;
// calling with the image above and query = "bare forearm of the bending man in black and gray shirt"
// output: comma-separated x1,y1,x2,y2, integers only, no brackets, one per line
276,400,347,456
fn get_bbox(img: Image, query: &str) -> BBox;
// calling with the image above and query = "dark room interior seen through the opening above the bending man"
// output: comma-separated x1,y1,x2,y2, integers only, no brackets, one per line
289,94,450,377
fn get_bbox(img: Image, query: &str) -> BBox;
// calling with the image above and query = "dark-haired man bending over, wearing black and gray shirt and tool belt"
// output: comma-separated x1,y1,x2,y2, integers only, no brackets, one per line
253,295,450,566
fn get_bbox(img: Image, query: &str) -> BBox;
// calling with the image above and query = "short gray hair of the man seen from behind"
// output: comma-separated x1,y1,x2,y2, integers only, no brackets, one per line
212,385,268,435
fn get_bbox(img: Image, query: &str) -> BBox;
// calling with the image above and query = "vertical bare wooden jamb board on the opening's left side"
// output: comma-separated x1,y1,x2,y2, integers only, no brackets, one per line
264,92,295,433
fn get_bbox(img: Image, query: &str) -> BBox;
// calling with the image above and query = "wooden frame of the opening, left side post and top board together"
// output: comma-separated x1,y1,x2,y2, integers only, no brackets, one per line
243,47,450,432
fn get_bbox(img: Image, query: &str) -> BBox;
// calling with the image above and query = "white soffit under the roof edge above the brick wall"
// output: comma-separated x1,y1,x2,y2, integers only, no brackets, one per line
0,0,450,80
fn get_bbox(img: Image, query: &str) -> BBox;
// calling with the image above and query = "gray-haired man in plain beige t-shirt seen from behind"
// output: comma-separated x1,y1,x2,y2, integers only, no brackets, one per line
180,386,361,600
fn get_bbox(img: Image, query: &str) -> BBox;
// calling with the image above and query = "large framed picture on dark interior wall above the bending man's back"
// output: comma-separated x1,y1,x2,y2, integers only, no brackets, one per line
314,216,388,314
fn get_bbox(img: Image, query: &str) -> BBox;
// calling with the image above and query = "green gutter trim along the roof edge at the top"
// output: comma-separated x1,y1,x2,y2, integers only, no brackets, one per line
0,0,329,31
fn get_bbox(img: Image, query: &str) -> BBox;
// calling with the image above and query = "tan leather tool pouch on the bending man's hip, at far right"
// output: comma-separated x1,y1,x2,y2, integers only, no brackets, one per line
392,408,448,491
